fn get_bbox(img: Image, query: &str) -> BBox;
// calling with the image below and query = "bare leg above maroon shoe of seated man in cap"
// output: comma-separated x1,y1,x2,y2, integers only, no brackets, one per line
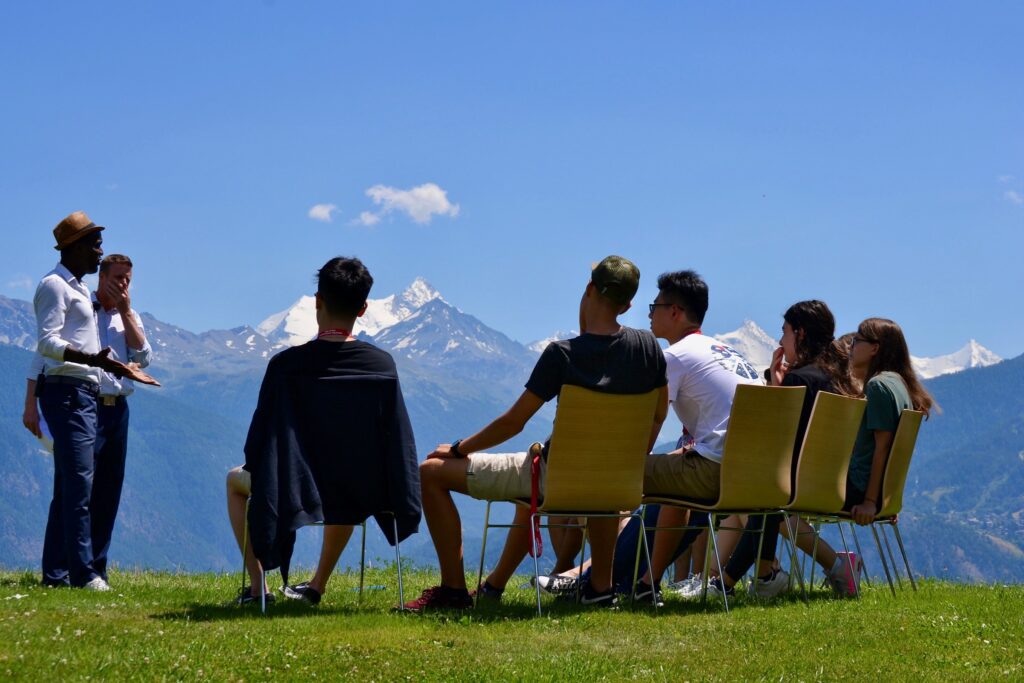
420,458,468,590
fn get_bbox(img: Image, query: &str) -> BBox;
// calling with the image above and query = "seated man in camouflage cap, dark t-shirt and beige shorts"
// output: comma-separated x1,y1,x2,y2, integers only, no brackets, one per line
406,256,668,611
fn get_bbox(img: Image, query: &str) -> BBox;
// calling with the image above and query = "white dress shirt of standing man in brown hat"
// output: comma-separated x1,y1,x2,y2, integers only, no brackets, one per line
33,263,101,384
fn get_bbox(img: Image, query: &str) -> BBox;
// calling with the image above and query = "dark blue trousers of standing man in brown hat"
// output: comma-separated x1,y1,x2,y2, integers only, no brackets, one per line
39,383,99,586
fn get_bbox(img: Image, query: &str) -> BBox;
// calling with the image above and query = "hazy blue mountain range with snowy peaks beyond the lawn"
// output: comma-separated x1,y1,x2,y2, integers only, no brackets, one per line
0,279,1024,581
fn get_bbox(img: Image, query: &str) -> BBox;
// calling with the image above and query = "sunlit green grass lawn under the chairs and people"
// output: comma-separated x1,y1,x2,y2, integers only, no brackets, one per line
0,570,1024,681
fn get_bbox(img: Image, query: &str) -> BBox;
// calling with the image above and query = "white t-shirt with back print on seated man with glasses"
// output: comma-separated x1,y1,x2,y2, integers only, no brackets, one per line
665,334,763,463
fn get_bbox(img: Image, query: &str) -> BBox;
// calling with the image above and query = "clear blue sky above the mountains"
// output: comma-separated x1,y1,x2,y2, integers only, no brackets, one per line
0,1,1024,356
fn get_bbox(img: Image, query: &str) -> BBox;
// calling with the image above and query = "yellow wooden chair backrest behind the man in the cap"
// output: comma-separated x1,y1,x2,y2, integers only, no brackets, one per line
542,385,659,512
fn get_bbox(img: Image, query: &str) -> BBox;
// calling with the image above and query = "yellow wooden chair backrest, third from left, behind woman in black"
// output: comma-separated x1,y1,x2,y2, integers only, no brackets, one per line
788,391,867,512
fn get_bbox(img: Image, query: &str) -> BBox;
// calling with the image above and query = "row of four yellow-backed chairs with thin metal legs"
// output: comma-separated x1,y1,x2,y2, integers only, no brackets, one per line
478,385,924,614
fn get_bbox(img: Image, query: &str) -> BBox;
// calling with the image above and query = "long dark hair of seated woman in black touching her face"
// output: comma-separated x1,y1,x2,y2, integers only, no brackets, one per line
782,299,859,396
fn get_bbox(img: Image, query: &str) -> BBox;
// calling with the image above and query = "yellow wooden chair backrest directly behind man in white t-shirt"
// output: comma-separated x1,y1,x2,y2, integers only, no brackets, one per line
717,384,807,510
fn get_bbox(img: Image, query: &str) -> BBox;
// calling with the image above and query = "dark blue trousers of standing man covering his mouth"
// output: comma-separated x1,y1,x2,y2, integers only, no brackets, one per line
89,398,128,581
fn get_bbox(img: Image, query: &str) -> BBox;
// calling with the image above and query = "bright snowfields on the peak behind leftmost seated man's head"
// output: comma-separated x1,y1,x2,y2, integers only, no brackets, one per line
256,278,443,346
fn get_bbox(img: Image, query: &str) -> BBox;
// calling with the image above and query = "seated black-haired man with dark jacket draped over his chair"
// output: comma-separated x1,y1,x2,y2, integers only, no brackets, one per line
227,257,419,605
